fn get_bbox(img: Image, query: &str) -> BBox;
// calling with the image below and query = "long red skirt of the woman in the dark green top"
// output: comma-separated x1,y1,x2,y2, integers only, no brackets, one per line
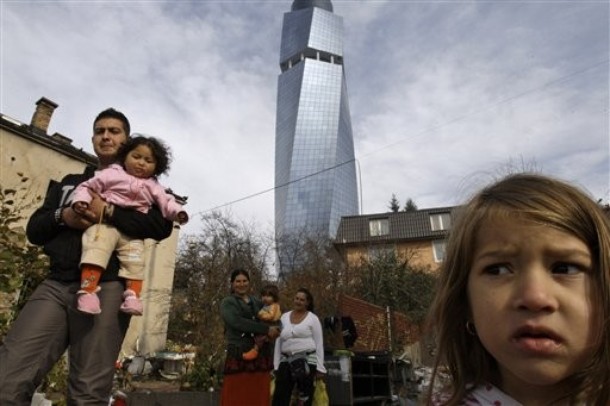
220,371,271,406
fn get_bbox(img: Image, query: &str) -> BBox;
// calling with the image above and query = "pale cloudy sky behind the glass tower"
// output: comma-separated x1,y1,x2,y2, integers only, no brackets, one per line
0,0,610,234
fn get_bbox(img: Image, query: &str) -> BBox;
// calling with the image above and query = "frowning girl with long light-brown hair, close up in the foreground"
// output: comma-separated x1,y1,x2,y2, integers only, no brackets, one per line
428,174,610,406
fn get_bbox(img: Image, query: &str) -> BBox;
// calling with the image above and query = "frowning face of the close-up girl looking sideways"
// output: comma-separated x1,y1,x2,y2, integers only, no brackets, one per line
468,218,599,404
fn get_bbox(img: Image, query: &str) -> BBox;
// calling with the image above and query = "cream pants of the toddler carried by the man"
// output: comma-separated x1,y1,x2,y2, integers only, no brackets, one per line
80,224,144,280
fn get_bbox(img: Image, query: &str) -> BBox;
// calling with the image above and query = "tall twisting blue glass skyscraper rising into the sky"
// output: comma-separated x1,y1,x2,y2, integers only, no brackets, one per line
275,0,358,251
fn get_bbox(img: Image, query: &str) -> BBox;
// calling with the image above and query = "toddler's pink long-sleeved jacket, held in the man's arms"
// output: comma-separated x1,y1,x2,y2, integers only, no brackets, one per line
72,164,184,221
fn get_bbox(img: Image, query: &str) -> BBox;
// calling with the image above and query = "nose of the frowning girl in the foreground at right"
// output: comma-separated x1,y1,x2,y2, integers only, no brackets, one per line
513,267,558,312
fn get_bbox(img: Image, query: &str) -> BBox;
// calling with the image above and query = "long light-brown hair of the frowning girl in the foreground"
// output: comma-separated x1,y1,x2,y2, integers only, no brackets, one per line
428,173,610,405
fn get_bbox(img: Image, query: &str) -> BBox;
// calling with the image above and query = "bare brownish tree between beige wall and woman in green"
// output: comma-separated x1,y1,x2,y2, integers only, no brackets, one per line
168,213,270,388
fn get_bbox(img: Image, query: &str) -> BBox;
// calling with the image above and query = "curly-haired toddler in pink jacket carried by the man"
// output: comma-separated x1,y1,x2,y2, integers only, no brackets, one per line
72,136,188,316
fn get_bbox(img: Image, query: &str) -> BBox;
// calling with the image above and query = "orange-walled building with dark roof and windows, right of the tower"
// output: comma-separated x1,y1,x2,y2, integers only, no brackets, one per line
334,207,455,272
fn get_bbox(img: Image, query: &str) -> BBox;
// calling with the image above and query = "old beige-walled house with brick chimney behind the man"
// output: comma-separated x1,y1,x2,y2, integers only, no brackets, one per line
0,97,179,355
